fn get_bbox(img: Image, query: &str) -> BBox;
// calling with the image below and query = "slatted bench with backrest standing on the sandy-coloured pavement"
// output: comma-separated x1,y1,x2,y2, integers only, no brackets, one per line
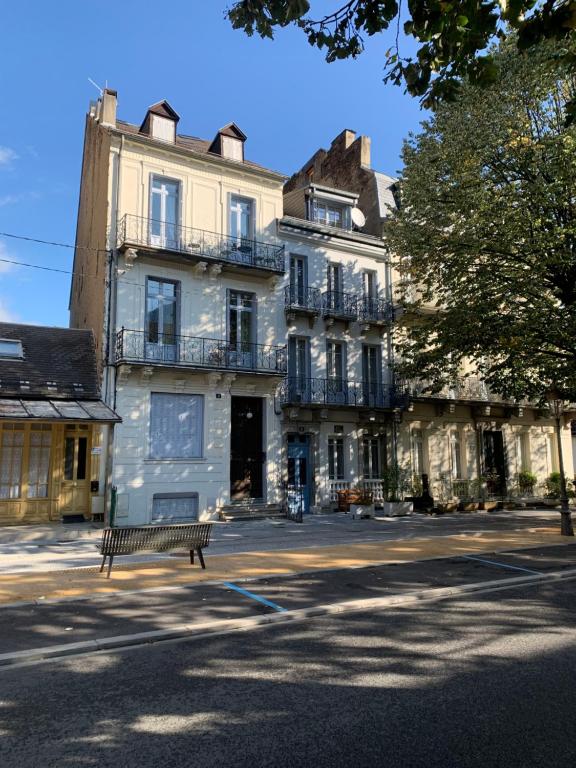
98,523,212,579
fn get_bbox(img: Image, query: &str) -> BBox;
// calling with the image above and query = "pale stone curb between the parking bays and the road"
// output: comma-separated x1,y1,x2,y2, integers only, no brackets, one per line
0,568,576,668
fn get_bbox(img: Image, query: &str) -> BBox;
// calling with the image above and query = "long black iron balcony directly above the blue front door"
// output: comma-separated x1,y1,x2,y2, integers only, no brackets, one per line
280,376,403,409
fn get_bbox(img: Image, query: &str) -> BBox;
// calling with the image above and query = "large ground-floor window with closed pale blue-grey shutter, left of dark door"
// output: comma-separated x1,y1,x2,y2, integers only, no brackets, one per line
150,392,204,459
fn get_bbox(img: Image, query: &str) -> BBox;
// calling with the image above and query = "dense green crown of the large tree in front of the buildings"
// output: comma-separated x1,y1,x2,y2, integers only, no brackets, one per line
386,41,576,400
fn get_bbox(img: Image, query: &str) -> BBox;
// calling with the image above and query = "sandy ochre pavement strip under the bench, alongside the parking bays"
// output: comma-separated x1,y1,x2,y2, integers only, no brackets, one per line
0,523,574,605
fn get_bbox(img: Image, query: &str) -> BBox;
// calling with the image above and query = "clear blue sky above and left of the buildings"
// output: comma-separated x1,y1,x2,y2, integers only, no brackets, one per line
0,0,423,326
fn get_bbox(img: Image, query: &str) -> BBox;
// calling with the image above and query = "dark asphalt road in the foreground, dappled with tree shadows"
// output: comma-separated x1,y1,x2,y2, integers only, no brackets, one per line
0,582,576,768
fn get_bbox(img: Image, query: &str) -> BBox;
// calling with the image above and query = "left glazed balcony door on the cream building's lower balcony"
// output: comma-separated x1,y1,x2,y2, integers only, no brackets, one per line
145,277,179,362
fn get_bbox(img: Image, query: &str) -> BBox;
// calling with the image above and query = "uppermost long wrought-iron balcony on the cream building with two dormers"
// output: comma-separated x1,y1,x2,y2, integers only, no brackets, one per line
118,213,285,275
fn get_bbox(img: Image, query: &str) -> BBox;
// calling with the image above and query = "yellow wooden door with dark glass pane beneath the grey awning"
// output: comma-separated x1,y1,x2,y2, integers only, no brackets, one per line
59,425,91,517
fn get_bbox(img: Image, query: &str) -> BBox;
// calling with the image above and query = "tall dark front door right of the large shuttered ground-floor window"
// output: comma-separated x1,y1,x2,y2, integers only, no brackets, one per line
230,397,266,501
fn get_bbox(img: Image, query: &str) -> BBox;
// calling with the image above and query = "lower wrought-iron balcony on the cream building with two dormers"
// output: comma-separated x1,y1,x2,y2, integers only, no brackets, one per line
115,328,286,376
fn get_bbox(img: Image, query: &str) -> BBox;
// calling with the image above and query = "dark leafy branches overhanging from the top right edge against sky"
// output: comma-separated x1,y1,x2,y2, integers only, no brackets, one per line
226,0,576,109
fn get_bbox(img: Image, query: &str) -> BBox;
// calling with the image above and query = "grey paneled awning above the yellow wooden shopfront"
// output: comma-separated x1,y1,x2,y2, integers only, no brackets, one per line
0,398,122,424
